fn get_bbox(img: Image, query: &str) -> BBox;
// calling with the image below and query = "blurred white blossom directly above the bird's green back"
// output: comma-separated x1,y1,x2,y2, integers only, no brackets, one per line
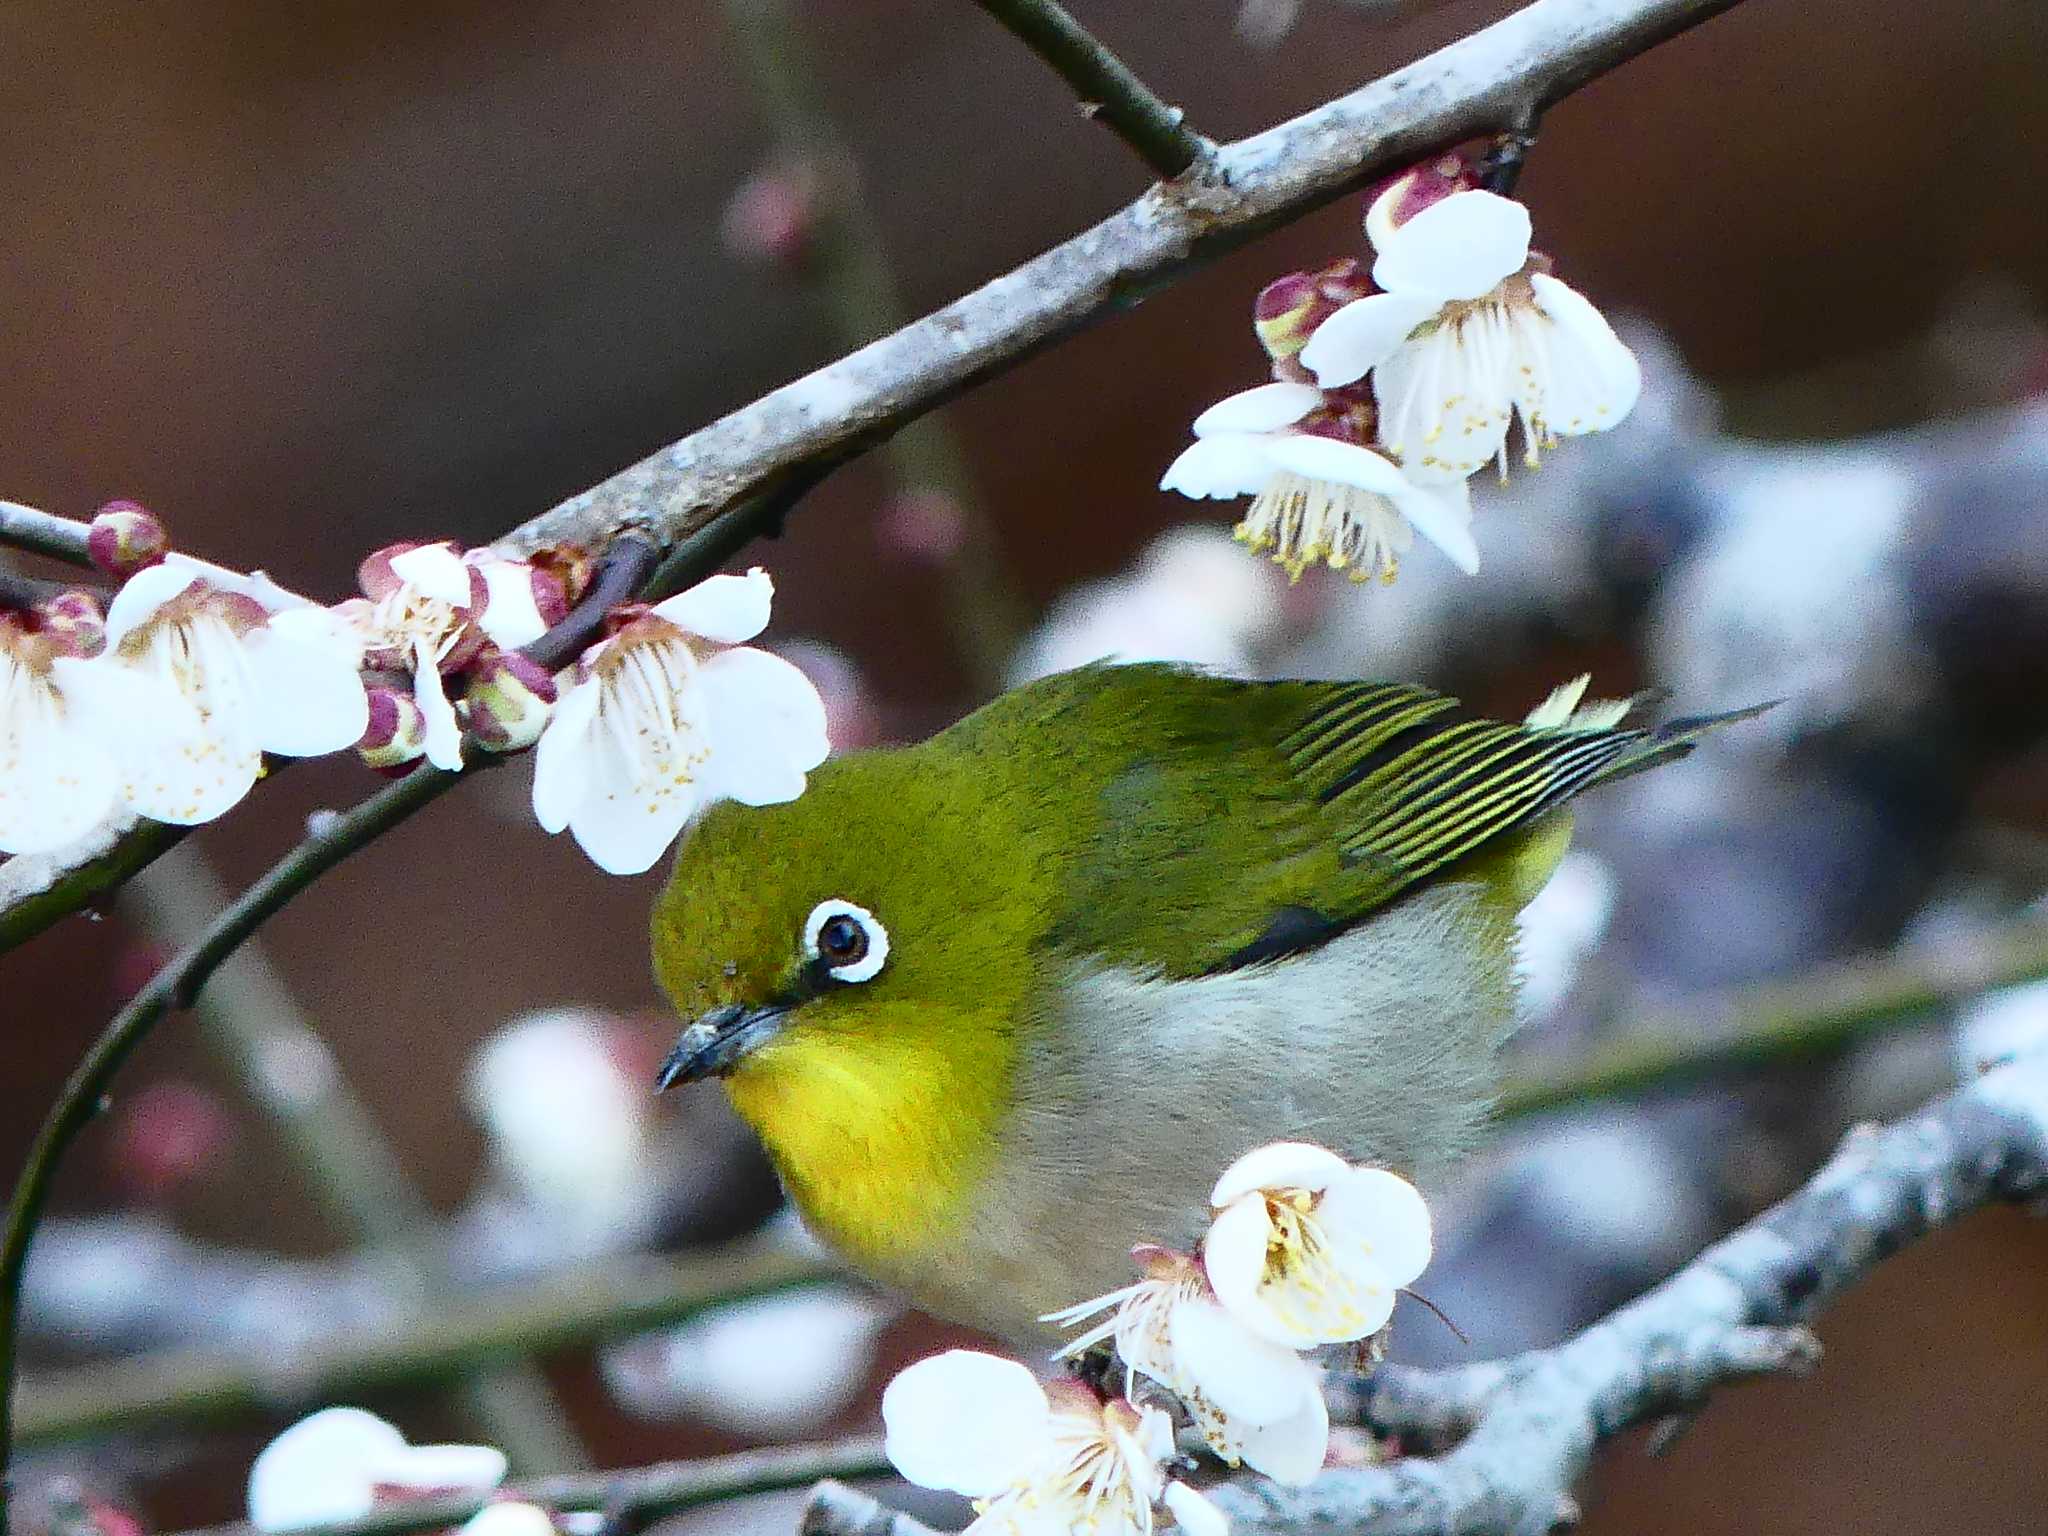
1010,526,1286,684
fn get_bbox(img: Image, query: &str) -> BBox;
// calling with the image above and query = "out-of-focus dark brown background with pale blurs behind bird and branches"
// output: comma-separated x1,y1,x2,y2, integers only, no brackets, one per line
0,0,2048,1536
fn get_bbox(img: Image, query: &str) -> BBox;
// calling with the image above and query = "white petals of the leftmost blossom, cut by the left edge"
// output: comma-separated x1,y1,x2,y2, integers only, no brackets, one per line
0,655,121,854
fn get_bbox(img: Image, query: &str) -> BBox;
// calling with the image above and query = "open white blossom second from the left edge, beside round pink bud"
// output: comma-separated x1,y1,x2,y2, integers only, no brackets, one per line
70,559,369,825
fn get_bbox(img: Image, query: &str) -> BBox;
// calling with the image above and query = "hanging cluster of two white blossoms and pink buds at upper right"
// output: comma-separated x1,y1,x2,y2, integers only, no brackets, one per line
1159,156,1642,582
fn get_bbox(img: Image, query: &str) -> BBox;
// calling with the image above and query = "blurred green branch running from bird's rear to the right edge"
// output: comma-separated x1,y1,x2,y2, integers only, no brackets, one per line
1495,918,2048,1120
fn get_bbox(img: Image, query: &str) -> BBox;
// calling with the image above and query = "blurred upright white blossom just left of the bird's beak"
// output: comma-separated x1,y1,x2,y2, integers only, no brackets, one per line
463,1008,657,1253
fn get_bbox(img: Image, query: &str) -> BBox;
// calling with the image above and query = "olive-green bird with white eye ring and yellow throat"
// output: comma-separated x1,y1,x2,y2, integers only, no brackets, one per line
653,666,1757,1341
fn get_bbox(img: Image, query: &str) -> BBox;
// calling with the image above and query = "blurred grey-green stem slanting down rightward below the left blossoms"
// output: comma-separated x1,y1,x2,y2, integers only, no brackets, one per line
129,850,588,1470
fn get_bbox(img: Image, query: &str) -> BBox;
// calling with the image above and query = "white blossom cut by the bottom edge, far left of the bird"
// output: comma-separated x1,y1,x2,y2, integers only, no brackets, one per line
248,1407,506,1532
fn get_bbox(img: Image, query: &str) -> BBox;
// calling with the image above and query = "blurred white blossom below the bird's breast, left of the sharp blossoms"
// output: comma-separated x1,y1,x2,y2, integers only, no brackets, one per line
602,1286,899,1438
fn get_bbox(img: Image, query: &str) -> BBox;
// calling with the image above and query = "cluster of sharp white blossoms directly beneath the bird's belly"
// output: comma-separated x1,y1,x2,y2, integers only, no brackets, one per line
883,1141,1432,1536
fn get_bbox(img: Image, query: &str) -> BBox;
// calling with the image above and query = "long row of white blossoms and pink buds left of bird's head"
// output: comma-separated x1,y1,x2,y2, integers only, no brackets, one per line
0,502,827,874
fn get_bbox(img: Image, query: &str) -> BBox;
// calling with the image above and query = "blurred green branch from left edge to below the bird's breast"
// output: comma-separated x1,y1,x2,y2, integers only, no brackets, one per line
16,1243,831,1444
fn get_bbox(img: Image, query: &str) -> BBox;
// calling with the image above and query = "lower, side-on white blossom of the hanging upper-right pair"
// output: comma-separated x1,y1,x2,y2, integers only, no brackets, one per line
1159,378,1479,582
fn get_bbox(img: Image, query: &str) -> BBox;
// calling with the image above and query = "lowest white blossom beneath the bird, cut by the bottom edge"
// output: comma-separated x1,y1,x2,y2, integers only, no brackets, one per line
883,1350,1227,1536
